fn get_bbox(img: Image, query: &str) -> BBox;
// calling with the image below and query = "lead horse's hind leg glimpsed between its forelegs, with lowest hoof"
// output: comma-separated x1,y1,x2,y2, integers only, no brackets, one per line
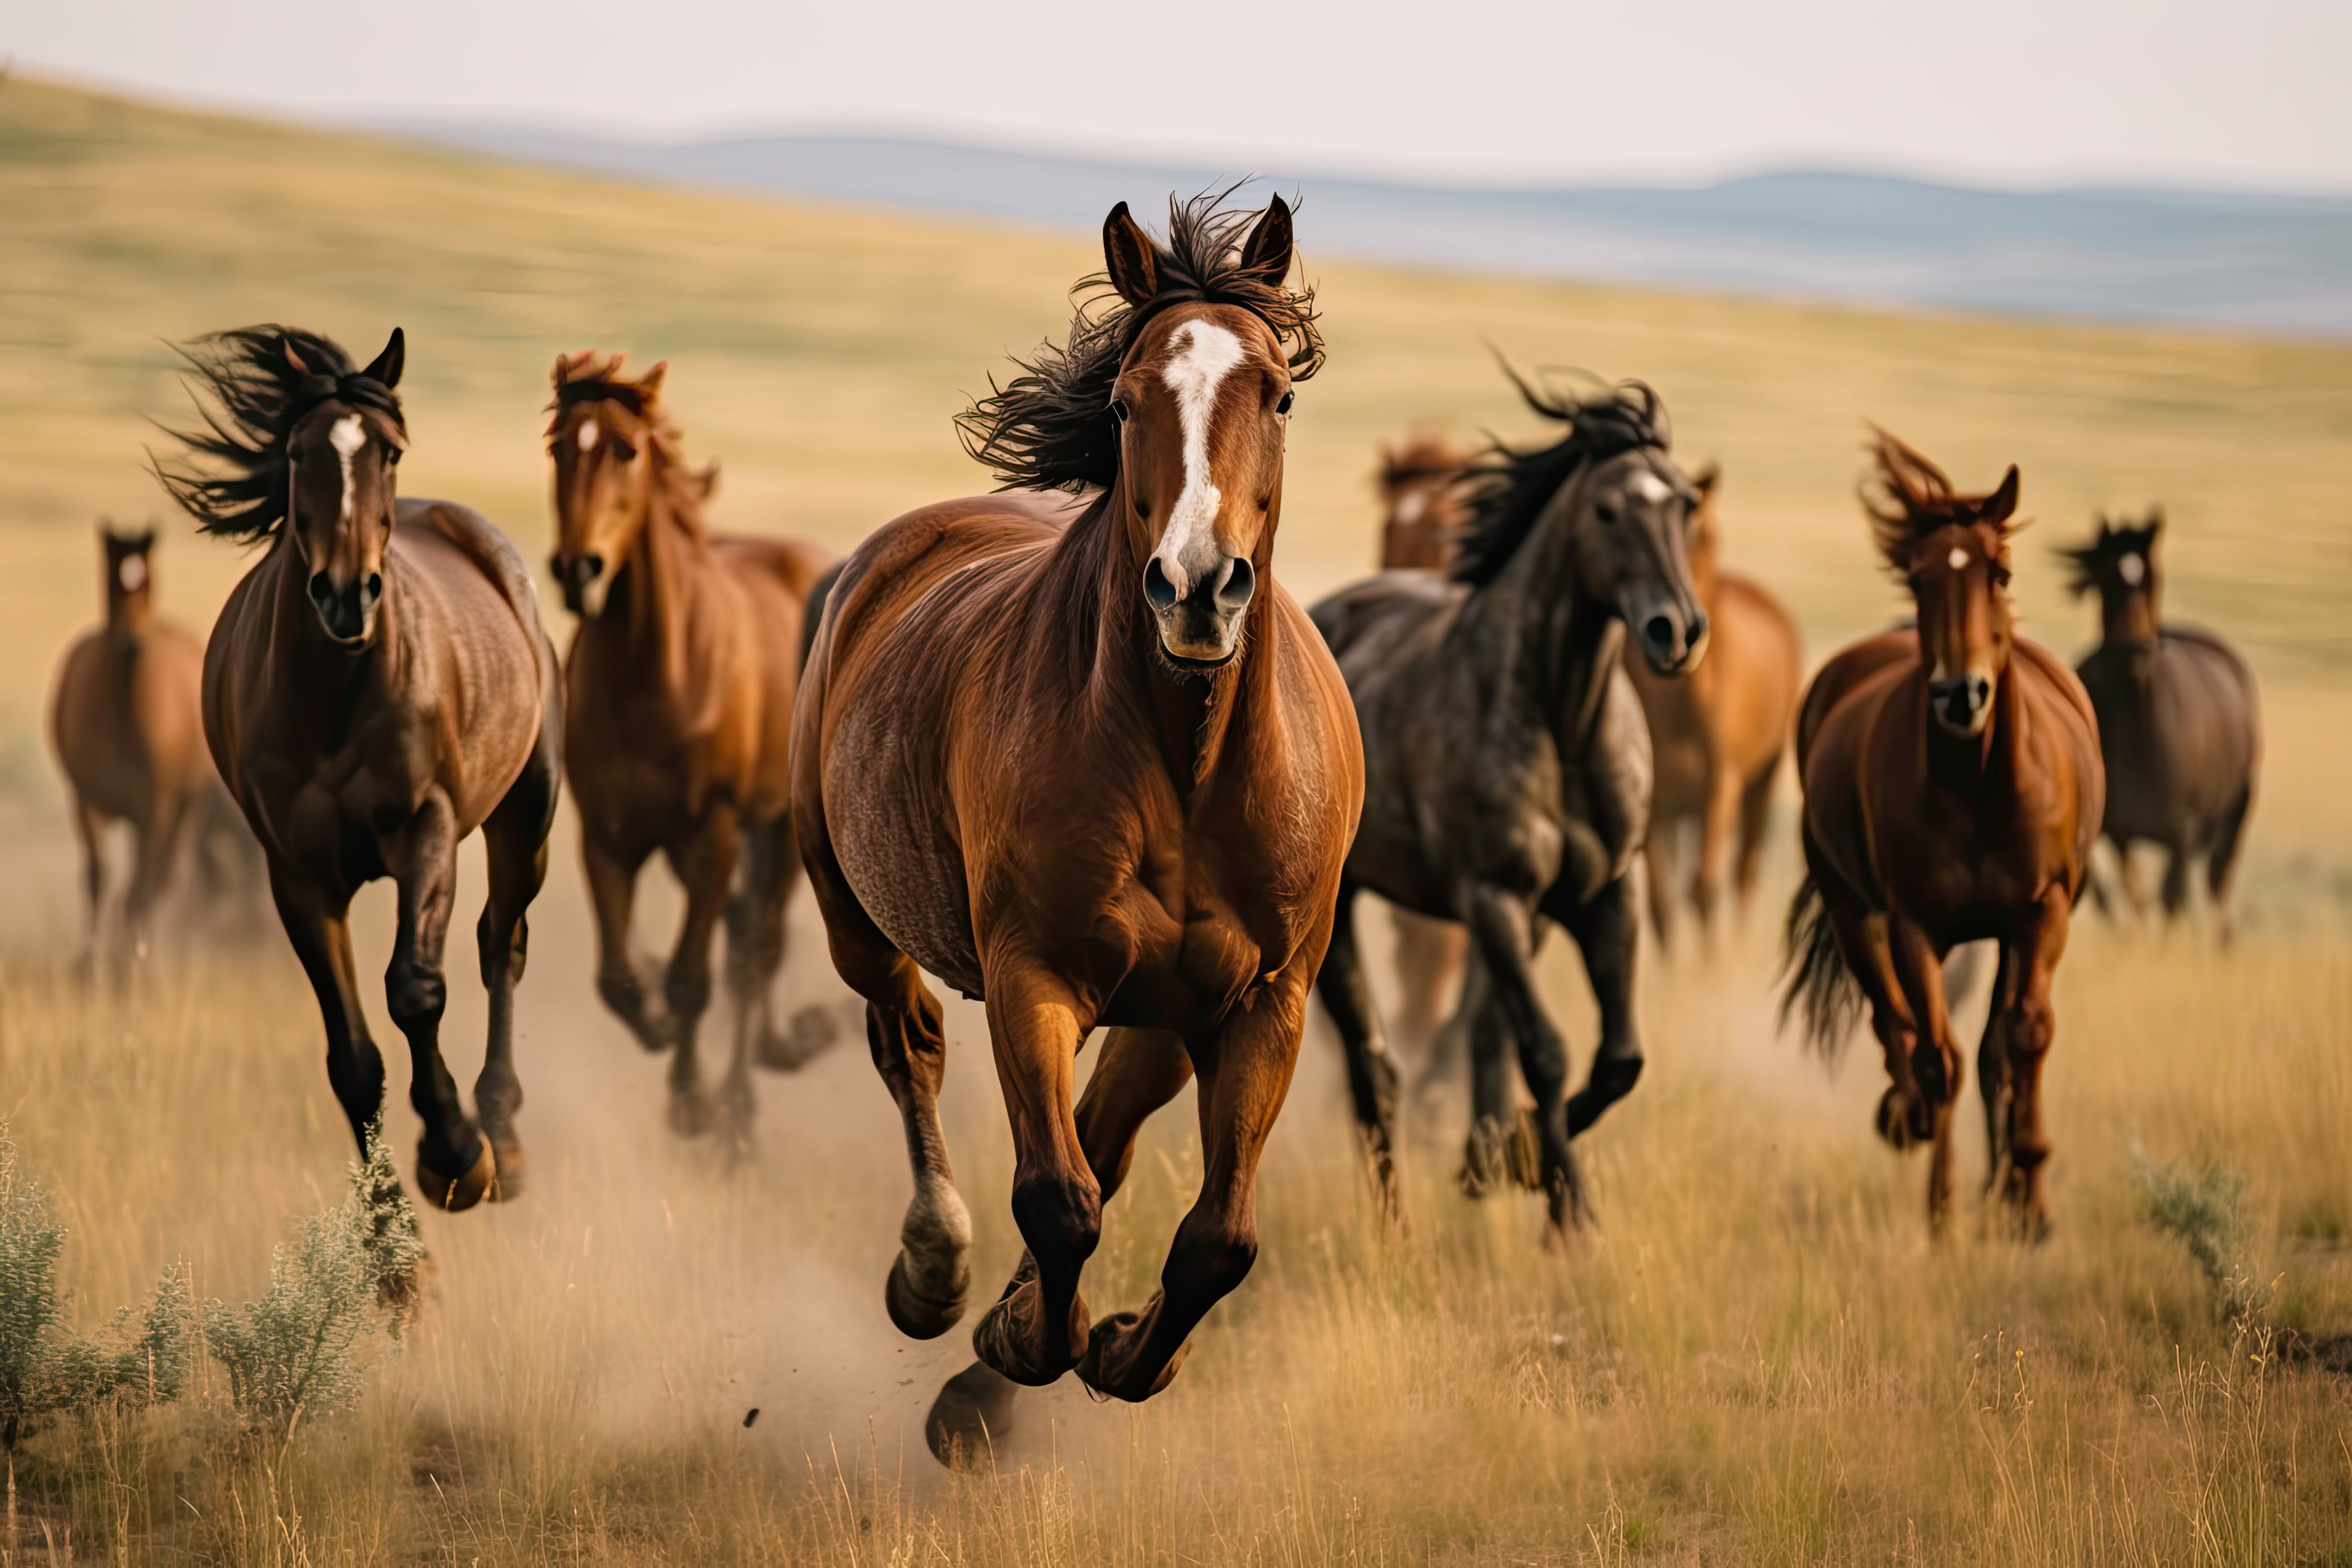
922,1030,1192,1469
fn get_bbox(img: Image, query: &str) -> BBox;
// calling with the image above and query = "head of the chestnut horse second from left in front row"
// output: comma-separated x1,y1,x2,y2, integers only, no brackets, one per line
548,353,696,621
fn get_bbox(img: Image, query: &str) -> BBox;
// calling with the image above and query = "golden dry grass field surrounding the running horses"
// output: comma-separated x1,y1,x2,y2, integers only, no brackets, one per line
0,78,2352,1566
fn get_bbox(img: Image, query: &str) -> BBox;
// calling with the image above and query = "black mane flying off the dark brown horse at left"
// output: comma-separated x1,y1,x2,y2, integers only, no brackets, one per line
148,325,407,538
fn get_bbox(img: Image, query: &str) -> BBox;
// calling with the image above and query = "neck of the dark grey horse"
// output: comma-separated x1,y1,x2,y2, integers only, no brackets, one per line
1456,496,1623,745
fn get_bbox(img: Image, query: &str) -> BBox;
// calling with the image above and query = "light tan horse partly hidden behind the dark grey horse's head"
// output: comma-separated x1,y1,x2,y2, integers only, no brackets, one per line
1625,468,1804,947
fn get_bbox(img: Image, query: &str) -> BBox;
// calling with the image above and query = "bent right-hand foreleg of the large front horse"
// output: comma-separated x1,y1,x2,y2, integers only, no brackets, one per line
1077,987,1305,1401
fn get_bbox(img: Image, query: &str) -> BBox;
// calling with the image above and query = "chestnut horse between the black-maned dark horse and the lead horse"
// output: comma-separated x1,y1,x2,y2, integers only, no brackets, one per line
548,353,833,1140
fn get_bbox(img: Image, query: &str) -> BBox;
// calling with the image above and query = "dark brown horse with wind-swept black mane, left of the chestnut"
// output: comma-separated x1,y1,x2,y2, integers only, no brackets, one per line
155,327,562,1210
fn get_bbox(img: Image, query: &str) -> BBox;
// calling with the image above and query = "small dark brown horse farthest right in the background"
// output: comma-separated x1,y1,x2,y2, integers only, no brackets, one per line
2058,510,2263,940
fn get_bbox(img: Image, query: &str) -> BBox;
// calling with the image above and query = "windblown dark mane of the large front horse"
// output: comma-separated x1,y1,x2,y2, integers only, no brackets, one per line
955,188,1324,491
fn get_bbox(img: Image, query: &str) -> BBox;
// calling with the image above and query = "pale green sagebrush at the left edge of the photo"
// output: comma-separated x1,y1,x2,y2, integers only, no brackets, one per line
0,1124,191,1448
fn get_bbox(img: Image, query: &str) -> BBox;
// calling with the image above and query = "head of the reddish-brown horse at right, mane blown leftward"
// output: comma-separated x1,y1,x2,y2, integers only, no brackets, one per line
1865,430,2018,738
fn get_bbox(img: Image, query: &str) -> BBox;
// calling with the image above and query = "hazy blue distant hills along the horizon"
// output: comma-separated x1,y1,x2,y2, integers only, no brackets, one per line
383,122,2352,339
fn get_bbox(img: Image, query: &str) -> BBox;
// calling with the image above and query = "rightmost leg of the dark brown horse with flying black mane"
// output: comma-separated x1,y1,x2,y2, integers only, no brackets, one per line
473,731,560,1201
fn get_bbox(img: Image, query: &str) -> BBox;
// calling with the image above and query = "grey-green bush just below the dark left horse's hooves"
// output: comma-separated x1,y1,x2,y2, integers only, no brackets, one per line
207,1133,426,1434
